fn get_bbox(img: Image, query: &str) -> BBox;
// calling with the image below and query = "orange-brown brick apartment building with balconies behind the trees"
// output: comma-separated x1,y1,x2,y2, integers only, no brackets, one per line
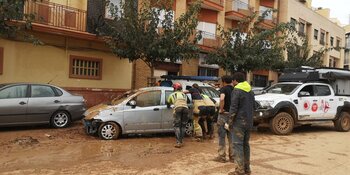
132,0,278,88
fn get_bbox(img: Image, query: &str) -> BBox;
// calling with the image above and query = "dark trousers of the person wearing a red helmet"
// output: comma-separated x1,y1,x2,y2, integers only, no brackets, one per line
173,107,188,144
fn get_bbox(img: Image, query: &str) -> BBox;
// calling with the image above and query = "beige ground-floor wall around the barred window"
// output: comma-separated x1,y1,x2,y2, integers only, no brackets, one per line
0,37,132,89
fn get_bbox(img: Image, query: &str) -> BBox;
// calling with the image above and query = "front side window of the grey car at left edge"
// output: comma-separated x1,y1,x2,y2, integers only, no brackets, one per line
0,85,28,99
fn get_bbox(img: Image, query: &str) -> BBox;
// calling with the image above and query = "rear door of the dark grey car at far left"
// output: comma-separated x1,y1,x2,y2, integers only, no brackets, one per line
27,84,61,123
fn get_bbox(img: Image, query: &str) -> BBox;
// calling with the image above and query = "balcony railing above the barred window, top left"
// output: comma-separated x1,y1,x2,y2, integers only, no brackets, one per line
24,0,86,31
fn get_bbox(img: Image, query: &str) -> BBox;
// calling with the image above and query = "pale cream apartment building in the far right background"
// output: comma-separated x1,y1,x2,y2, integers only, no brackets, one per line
279,0,345,68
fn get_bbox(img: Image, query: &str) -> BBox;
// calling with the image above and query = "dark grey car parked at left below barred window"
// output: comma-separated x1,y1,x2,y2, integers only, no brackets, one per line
0,83,85,128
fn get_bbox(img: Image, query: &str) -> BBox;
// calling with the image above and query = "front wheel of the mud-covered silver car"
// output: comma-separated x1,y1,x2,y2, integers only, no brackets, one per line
98,122,120,140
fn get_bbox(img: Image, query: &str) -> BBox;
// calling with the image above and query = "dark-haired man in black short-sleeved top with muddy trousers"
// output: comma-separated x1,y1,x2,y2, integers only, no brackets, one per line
214,75,234,163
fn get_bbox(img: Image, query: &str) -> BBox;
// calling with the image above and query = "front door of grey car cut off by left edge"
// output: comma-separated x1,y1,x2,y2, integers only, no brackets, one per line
0,84,28,125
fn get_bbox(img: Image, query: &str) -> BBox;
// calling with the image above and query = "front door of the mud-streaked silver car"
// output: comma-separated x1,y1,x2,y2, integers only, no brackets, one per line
124,90,162,132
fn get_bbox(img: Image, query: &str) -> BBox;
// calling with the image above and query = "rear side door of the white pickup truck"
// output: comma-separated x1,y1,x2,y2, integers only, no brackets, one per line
315,85,337,119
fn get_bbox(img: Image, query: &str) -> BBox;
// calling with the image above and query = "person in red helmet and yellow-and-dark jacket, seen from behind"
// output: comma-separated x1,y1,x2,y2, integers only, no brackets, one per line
167,83,189,148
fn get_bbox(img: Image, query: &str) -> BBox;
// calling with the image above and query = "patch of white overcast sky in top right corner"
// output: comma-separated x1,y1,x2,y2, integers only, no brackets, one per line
312,0,350,24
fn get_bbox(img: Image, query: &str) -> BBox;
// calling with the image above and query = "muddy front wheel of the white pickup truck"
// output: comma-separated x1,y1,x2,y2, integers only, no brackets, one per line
270,112,294,135
